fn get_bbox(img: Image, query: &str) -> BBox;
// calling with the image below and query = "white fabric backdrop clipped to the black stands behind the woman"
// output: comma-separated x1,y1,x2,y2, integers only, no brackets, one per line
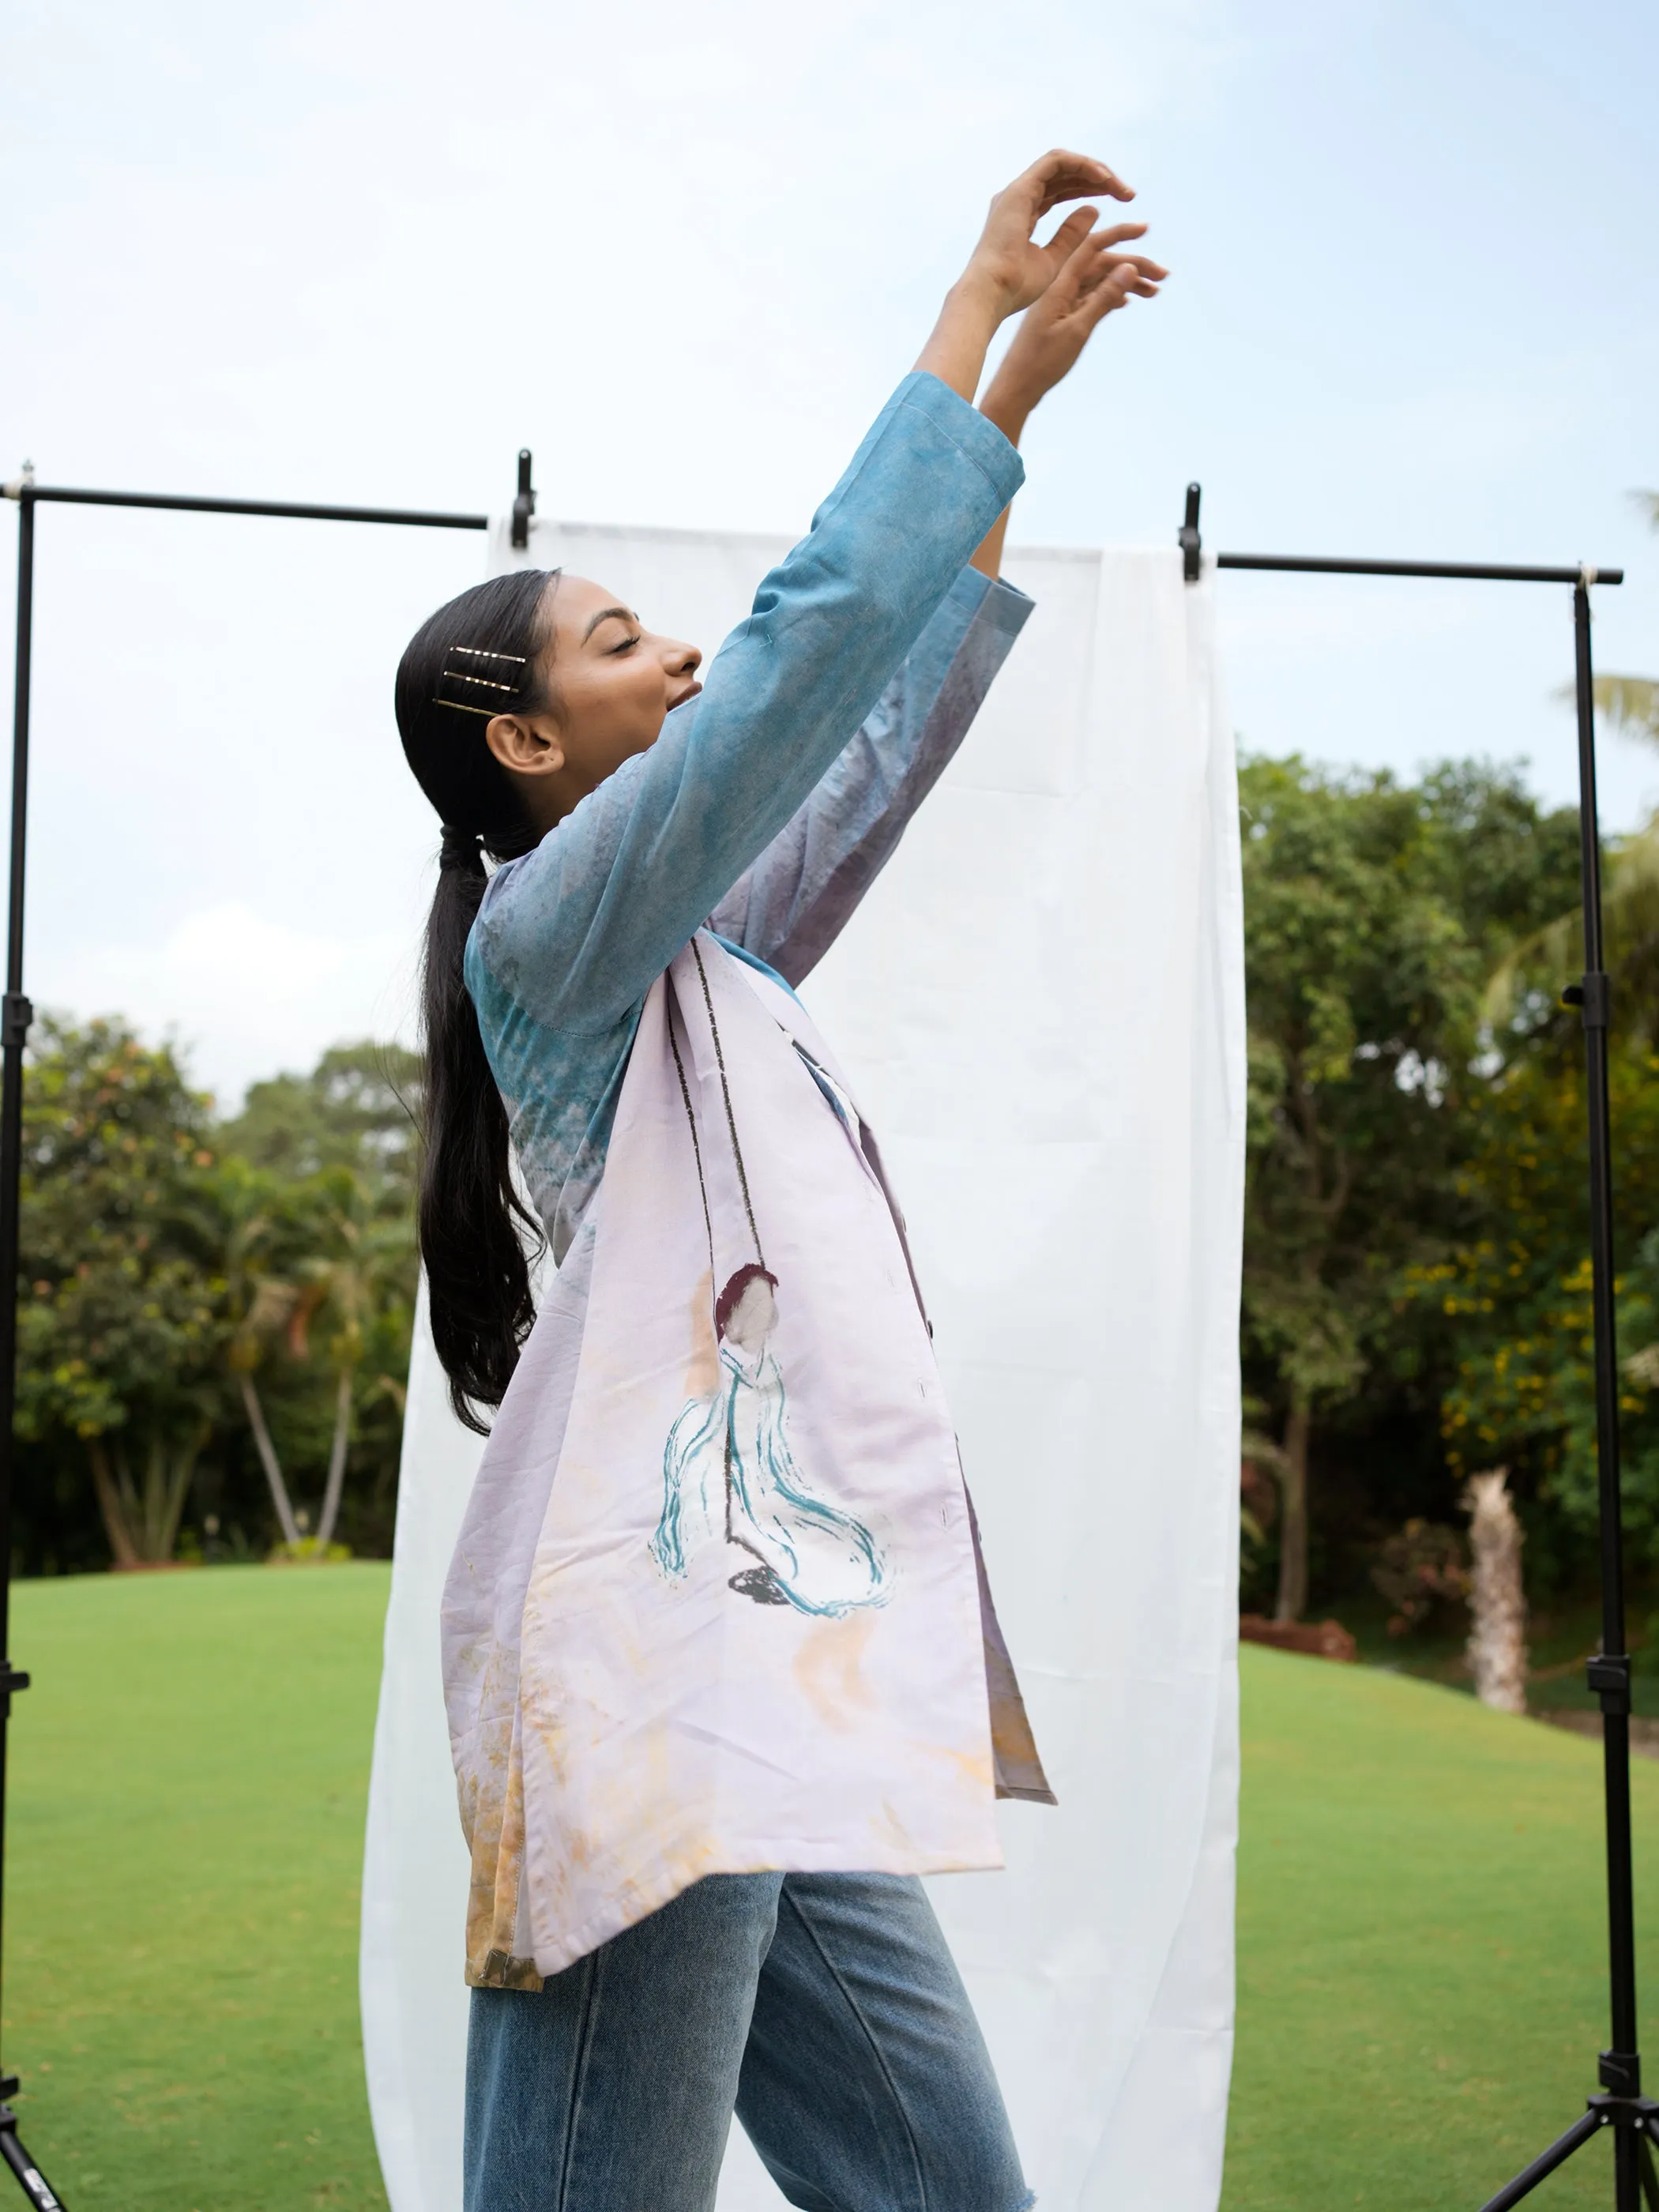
363,509,1243,2212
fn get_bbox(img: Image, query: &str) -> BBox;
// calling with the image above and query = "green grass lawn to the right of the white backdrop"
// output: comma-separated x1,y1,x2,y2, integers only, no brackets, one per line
1223,1648,1659,2212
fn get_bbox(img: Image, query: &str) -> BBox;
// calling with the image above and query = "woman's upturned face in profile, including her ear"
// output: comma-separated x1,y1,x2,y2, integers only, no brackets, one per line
484,575,703,830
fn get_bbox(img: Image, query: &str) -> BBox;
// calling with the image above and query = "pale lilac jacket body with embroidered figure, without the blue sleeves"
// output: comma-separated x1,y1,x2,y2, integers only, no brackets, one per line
445,931,1035,1982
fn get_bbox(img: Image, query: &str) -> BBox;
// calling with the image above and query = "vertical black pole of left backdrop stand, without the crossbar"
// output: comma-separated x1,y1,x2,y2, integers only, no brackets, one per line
0,502,60,2212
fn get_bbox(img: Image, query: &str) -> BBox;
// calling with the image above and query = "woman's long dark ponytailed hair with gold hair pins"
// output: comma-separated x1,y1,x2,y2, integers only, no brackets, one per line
396,569,558,1435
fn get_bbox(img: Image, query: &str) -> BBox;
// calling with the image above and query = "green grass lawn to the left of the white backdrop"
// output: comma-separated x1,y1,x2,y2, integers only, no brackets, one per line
5,1564,389,2212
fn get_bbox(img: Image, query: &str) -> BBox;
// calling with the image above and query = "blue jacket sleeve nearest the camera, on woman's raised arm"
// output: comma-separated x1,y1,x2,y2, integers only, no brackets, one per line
467,374,1024,1035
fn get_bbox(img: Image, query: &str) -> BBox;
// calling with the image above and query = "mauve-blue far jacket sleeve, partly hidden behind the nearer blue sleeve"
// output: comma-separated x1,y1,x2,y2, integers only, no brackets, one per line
710,569,1031,984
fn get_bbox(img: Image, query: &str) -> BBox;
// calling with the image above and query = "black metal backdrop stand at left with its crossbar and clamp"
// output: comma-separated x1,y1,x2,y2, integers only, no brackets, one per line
0,449,536,2212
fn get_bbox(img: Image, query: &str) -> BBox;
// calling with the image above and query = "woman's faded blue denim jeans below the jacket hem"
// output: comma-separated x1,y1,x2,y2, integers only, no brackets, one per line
465,1874,1033,2212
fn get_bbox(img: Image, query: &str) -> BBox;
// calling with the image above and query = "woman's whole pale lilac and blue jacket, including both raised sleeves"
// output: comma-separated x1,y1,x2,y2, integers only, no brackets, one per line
445,376,1048,1986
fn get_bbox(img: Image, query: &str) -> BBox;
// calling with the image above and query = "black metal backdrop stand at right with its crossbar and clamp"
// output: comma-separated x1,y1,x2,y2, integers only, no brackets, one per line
1177,484,1659,2212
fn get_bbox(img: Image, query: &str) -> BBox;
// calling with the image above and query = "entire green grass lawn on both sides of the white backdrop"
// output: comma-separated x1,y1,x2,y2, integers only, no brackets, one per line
0,1564,1659,2212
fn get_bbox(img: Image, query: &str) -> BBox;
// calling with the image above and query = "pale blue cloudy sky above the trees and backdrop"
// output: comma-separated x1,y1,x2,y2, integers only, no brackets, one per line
0,0,1659,1104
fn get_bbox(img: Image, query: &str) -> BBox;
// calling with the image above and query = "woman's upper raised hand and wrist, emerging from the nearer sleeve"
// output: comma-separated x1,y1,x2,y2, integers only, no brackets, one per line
916,152,1134,401
